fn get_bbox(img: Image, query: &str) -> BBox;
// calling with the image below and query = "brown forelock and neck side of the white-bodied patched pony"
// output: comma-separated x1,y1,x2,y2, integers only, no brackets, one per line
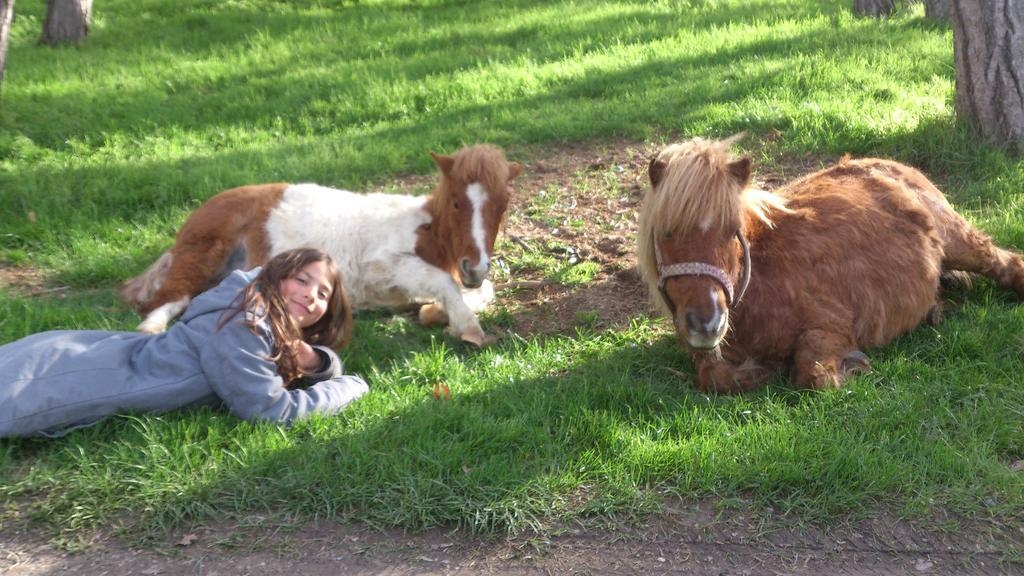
417,145,509,274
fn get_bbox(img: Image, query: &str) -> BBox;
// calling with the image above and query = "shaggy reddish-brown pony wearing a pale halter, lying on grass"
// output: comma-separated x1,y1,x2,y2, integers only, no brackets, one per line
638,137,1024,393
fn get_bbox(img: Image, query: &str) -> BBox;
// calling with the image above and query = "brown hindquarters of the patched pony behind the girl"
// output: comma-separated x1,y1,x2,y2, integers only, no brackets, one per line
121,182,288,315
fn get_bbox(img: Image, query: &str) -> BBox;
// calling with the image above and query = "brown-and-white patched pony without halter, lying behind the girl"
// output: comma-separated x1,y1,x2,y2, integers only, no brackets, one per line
122,145,522,344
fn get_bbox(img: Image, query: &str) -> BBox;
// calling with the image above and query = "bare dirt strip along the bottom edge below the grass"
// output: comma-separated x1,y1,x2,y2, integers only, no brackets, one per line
0,501,1024,576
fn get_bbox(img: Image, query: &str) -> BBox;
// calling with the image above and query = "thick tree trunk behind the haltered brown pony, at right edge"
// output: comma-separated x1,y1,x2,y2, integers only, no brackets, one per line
950,0,1024,149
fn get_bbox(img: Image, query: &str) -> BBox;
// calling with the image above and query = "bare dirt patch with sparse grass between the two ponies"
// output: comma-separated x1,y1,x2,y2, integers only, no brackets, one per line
503,141,655,335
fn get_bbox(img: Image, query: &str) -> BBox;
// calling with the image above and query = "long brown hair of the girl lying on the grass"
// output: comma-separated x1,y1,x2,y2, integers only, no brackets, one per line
218,248,352,387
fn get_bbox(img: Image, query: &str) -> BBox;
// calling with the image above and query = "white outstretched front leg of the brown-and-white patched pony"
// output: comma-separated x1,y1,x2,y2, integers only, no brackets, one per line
395,258,494,345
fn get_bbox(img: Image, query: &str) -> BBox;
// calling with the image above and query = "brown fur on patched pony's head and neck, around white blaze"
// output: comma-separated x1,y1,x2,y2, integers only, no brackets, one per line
416,145,522,278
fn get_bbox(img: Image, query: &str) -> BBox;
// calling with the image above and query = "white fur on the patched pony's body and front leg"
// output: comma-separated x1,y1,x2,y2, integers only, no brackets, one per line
266,183,494,335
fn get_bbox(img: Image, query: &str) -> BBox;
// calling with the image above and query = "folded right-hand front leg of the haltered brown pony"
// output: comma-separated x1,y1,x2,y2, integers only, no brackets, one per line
793,329,871,389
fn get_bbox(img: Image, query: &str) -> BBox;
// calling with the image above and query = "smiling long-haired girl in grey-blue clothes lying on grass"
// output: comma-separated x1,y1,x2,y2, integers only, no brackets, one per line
0,243,369,438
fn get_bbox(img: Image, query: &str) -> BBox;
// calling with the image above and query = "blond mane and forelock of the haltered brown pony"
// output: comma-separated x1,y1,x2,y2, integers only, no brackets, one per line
637,134,787,303
